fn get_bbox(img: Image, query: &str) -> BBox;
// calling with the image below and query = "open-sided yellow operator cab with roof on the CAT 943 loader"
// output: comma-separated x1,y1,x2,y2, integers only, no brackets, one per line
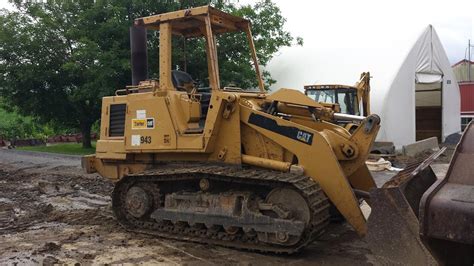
126,6,264,134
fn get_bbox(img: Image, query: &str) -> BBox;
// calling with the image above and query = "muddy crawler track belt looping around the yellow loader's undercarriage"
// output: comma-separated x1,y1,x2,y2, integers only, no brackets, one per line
112,164,329,254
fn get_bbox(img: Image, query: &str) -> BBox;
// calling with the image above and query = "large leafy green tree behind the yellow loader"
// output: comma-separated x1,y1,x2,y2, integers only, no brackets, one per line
0,0,302,148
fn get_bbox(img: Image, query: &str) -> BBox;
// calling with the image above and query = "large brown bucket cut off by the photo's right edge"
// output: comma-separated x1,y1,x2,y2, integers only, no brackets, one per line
420,122,474,265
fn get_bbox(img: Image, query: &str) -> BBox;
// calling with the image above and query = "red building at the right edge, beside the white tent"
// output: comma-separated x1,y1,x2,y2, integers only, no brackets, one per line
453,59,474,130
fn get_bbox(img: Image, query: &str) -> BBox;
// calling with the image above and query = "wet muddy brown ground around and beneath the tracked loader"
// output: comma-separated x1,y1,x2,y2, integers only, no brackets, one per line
0,150,446,265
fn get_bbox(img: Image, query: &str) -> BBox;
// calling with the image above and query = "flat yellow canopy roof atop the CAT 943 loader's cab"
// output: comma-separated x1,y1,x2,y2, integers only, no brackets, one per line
135,6,249,37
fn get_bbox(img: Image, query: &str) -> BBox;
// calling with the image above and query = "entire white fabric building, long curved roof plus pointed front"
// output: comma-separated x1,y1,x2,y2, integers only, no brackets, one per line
268,25,460,148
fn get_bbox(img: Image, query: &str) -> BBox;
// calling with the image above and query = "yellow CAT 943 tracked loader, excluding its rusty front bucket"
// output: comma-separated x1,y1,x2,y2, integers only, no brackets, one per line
82,6,472,262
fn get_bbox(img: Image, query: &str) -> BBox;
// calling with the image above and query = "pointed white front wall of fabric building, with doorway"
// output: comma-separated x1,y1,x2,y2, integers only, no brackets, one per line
379,25,461,147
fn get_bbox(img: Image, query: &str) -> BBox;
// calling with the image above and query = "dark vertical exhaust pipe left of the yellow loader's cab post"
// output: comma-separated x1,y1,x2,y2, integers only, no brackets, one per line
130,26,148,85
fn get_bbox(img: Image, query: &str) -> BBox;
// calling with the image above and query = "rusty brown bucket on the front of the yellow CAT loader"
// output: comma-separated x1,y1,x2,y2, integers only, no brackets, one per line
366,148,445,265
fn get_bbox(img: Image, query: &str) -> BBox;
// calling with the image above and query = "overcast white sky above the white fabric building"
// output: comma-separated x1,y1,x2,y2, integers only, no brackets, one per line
262,0,474,63
